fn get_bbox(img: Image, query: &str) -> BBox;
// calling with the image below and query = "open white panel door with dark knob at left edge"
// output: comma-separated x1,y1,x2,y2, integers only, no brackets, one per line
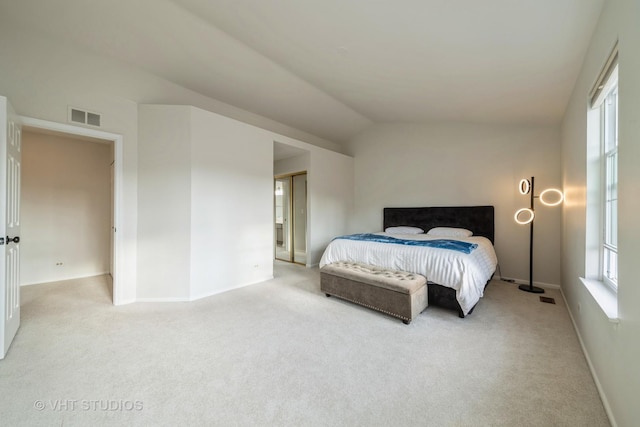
0,96,22,359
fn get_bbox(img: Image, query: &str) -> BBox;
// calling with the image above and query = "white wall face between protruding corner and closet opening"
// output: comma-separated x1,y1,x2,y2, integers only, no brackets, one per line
190,108,274,298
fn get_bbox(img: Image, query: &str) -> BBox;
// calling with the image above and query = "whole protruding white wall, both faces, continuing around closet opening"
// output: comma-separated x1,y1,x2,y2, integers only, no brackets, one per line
137,105,353,301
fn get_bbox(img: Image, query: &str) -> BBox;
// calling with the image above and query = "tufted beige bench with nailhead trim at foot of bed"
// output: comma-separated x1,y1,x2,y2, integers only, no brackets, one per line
320,261,428,324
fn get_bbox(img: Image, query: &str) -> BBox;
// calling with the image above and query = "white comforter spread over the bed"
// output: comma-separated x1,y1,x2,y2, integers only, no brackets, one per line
320,233,498,315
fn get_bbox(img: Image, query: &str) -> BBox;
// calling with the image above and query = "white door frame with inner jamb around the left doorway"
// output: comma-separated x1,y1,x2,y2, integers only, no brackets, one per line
21,117,126,305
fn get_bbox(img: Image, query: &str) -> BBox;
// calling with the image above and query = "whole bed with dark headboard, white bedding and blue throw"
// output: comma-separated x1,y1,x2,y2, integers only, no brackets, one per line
320,206,497,317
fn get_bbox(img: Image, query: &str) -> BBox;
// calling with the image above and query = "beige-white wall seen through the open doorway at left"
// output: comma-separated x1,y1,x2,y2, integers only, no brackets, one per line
20,131,113,285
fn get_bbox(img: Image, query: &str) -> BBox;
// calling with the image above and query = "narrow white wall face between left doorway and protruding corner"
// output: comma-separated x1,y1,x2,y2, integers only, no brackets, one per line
137,105,191,300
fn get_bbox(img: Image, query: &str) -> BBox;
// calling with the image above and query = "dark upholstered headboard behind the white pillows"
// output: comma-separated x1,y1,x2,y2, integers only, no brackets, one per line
383,206,495,243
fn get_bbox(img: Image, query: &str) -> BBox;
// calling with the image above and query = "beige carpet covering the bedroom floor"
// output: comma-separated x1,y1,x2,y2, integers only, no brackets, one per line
0,263,609,426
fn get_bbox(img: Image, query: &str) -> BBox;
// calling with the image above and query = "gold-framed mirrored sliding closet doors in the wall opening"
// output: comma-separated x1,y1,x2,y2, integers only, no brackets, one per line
274,171,307,265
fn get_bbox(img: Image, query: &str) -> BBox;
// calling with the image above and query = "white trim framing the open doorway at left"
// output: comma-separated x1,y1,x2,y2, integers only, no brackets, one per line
20,116,127,305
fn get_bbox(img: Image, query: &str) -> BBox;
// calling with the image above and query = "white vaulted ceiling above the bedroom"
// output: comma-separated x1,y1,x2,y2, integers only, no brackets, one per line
0,0,604,142
